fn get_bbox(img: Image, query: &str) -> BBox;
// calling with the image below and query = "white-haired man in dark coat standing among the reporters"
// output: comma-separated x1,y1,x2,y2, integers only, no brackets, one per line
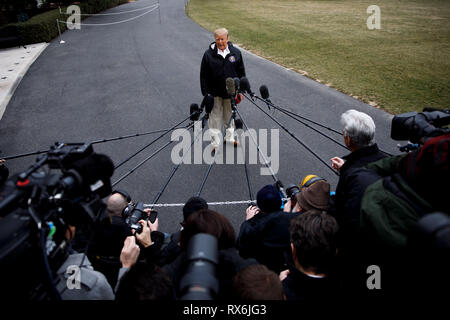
328,110,386,288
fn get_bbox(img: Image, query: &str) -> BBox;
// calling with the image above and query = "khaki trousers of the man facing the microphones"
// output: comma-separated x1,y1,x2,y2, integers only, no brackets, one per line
208,97,235,147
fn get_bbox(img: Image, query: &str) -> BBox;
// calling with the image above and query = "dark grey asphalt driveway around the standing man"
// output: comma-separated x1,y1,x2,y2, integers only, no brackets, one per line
0,0,398,233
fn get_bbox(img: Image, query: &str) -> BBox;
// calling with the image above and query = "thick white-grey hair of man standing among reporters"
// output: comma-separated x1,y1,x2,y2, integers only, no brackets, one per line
341,109,375,148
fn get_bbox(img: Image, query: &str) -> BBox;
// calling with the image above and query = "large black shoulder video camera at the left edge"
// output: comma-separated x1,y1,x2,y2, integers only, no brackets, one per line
0,143,114,300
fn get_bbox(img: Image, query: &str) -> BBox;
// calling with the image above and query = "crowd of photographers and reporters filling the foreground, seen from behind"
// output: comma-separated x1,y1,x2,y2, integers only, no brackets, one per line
0,110,450,302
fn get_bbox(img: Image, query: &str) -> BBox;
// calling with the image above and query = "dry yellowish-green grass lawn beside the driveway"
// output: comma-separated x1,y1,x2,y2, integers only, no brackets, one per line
187,0,450,114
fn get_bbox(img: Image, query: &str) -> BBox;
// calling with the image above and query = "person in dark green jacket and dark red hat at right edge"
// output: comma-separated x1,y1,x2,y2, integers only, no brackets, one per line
339,134,450,296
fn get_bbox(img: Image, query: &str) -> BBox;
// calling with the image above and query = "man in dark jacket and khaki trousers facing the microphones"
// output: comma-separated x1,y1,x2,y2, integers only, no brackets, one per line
200,28,245,149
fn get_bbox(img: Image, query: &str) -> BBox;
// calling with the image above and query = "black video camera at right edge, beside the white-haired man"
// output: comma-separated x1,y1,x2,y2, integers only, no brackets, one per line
391,108,450,143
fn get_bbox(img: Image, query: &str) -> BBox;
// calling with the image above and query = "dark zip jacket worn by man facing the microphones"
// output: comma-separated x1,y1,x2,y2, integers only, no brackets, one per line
200,42,245,98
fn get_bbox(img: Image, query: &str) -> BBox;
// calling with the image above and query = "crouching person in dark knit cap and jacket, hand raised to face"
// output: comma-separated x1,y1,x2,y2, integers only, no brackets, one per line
237,185,298,273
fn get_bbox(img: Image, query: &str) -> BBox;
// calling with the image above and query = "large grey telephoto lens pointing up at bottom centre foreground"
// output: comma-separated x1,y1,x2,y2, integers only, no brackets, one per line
180,233,219,300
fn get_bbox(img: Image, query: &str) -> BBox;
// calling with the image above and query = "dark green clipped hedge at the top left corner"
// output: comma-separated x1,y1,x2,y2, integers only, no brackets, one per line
0,0,128,44
